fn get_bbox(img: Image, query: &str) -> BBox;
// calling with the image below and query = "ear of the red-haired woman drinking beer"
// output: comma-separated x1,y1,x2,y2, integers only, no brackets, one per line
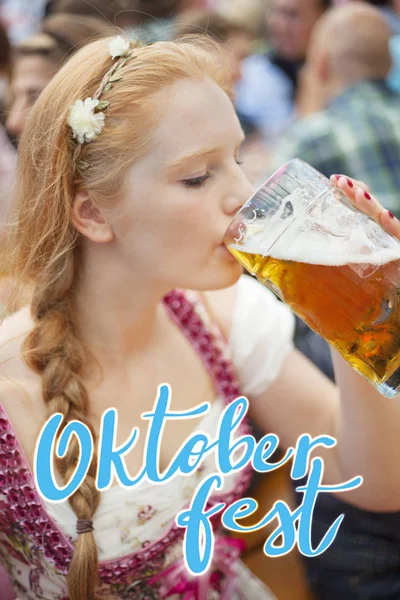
71,191,114,243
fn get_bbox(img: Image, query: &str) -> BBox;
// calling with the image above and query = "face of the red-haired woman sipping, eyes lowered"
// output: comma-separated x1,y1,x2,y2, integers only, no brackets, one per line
103,79,253,290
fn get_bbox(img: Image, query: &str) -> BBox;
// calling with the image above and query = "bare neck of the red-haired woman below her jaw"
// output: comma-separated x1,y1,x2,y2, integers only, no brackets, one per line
75,245,169,367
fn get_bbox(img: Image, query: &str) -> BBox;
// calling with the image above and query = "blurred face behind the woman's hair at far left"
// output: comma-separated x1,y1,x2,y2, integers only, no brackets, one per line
6,55,57,140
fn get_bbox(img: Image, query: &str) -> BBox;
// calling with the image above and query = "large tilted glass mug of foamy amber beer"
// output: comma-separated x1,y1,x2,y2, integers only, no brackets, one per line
224,159,400,397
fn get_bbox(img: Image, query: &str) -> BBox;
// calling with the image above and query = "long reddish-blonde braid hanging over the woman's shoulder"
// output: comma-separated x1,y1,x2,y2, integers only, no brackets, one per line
23,250,100,600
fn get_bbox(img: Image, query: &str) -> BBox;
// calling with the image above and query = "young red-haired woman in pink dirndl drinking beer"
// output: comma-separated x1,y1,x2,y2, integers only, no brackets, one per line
0,38,400,600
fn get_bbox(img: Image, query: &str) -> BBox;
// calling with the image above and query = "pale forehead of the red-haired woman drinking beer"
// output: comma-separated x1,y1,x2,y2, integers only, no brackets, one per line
148,79,242,160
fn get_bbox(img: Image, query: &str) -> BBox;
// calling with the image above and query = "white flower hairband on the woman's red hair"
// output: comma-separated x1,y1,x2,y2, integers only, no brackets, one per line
68,35,138,148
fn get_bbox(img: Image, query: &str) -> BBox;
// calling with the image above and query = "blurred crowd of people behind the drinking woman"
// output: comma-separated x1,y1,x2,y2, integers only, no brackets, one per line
0,0,400,600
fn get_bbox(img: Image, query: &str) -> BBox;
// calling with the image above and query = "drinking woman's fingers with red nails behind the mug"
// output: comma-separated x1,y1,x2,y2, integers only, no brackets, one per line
330,175,400,239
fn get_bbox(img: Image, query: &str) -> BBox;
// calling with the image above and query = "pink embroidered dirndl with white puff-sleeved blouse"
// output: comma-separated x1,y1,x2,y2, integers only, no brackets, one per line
0,275,294,600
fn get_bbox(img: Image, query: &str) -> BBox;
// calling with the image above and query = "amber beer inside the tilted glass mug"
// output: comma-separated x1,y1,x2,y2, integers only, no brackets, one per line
229,239,400,392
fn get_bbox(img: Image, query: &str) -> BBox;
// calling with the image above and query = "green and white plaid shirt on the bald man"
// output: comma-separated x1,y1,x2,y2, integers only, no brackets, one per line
273,81,400,217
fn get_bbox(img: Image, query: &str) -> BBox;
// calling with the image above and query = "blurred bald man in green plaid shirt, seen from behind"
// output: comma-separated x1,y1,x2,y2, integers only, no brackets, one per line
274,7,400,600
